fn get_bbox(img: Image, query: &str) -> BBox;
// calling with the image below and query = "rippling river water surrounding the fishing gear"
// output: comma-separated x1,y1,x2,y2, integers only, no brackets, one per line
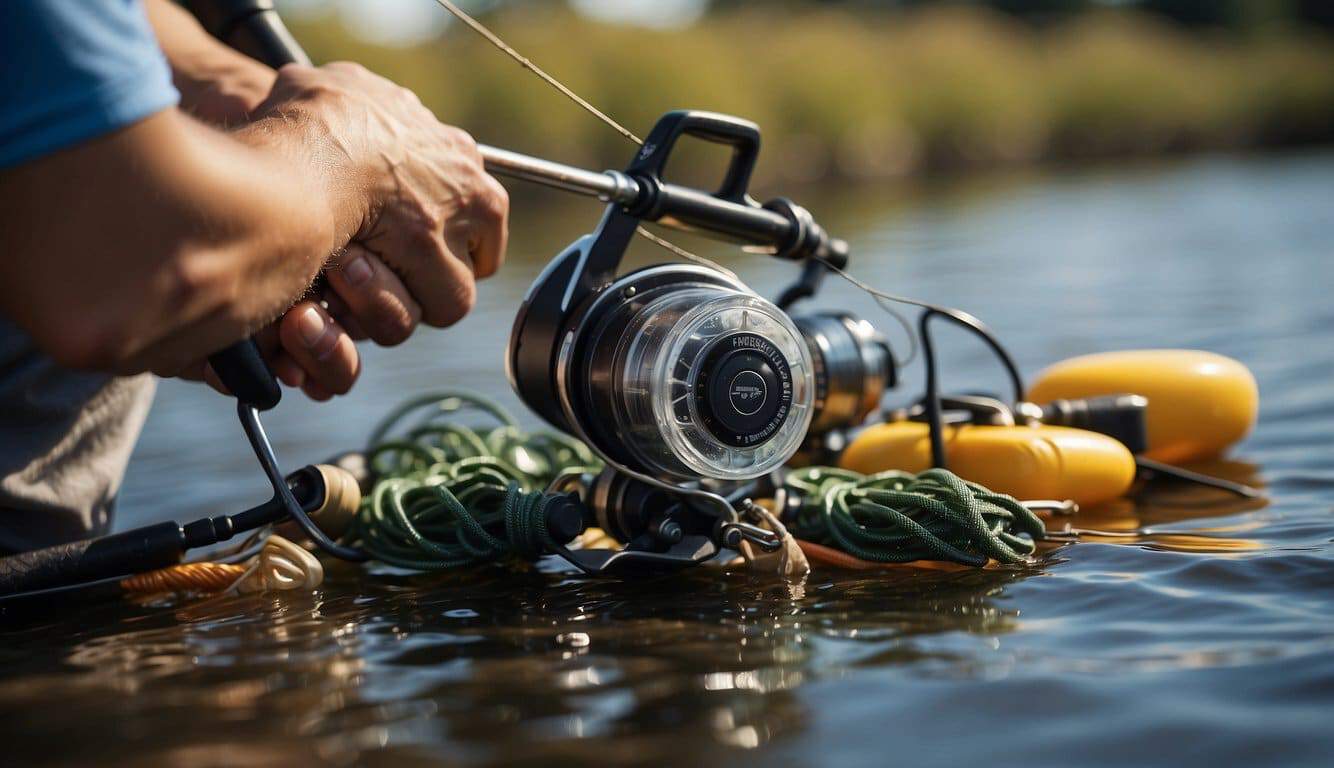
0,153,1334,768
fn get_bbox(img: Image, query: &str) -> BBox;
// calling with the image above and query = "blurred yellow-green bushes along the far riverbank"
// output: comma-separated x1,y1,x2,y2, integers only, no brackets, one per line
293,5,1334,183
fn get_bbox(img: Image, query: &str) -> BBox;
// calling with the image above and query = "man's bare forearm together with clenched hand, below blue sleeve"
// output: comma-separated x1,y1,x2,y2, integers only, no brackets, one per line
0,52,508,392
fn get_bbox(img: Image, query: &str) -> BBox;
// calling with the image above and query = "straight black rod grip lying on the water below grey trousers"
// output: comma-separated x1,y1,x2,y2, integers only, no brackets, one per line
0,523,185,597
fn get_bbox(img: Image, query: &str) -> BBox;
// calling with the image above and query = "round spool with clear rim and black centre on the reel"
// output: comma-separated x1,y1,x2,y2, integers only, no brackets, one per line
528,265,815,480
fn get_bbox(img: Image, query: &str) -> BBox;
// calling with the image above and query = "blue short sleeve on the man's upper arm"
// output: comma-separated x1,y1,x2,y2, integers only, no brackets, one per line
0,0,179,168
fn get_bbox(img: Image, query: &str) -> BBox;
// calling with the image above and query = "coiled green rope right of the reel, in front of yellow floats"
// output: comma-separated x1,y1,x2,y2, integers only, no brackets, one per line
786,467,1046,567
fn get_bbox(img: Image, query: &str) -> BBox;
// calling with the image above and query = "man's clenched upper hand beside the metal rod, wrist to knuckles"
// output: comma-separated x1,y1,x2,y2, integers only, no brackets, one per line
257,63,510,344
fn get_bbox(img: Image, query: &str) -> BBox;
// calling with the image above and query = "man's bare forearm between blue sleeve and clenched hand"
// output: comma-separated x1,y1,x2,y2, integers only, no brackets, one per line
0,111,366,372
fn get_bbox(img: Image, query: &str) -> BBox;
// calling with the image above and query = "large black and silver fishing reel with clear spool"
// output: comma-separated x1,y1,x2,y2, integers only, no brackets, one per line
506,112,896,571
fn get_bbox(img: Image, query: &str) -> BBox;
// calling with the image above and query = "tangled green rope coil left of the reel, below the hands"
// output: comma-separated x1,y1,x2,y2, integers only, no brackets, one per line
350,392,600,571
